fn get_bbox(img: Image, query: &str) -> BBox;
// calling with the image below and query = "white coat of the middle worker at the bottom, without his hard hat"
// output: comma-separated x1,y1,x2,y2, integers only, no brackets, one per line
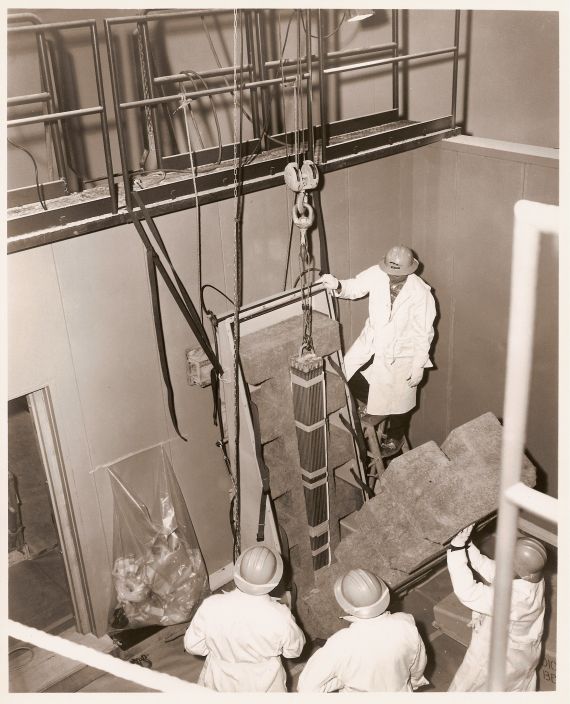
298,611,429,693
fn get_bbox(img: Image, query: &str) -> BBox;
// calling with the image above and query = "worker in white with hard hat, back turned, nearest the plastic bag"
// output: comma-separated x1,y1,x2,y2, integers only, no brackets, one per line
184,545,305,692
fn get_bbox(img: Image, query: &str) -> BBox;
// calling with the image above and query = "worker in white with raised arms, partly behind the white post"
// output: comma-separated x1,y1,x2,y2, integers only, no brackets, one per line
447,525,546,692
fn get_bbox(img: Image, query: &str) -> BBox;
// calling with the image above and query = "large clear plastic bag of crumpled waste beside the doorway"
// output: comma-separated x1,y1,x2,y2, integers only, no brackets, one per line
108,446,209,629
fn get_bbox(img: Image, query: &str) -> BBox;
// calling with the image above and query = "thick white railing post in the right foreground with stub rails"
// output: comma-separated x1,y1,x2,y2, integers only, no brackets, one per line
487,200,559,692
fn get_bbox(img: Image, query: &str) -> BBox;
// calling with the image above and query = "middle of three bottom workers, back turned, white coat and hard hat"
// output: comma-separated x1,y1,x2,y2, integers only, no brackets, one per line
298,569,429,693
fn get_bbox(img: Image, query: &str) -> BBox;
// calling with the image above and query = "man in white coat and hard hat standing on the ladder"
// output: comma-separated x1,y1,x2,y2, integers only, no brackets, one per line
320,245,436,454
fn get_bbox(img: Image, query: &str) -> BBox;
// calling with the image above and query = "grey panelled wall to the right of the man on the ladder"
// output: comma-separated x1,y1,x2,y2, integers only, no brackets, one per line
410,138,558,496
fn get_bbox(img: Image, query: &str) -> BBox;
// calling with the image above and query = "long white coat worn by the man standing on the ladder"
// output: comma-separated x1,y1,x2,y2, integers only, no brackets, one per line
337,264,436,415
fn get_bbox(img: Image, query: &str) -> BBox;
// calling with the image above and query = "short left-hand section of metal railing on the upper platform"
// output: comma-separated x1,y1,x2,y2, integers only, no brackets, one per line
6,13,118,213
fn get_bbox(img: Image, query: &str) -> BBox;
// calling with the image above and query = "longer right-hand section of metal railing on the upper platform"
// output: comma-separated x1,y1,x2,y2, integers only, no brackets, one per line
105,9,460,207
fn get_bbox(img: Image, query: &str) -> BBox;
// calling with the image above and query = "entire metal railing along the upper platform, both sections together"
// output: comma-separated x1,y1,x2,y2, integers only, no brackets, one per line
7,8,460,231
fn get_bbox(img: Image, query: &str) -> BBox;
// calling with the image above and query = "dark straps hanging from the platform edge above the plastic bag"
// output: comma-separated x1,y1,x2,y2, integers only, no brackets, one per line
129,191,223,440
